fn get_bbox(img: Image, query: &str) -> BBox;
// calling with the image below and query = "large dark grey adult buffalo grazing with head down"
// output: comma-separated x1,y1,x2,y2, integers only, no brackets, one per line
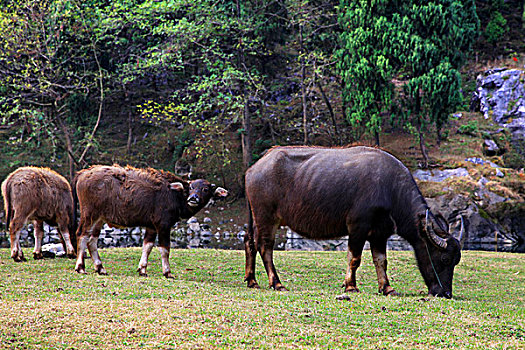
245,146,461,298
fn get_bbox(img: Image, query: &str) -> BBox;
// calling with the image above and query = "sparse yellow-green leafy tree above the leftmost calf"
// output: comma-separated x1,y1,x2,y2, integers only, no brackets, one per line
0,0,104,176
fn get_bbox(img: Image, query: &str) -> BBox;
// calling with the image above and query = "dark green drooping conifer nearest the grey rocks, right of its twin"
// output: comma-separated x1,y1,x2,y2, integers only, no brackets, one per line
396,0,479,166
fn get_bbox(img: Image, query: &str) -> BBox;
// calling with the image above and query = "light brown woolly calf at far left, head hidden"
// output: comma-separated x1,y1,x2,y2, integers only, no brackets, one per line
2,167,76,262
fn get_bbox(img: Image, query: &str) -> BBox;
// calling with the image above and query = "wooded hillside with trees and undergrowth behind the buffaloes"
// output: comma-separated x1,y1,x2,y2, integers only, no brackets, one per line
0,0,525,216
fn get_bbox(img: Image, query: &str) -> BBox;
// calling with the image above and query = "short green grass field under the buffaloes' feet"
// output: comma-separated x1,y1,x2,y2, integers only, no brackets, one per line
0,248,525,349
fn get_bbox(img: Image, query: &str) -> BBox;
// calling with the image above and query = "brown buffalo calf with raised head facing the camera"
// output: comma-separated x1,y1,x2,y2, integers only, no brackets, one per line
73,165,228,278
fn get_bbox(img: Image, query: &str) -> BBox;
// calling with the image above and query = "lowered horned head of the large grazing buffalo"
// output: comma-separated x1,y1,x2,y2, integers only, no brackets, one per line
416,210,464,299
